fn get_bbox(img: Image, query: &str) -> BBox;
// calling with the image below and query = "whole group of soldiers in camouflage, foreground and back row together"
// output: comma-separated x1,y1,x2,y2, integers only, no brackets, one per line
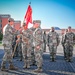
1,18,75,72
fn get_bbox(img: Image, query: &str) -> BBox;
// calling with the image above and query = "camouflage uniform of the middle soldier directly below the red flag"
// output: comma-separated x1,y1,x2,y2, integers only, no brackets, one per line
22,29,31,68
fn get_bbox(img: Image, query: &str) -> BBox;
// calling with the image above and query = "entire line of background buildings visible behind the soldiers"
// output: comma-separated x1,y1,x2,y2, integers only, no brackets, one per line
0,14,75,35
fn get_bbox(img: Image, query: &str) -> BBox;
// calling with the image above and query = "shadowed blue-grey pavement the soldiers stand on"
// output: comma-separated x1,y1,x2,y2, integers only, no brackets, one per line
0,44,75,75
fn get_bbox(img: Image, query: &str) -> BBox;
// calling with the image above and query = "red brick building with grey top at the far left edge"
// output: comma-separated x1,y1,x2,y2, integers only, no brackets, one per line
0,14,11,32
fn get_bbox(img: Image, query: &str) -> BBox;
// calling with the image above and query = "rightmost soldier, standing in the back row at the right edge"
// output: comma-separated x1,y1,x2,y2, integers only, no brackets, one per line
64,26,75,62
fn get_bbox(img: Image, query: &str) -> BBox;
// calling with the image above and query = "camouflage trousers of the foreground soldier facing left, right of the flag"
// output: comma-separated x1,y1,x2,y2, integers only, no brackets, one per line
34,48,43,68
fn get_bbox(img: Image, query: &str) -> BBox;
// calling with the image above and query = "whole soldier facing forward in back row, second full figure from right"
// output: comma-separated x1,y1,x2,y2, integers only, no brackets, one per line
47,27,60,61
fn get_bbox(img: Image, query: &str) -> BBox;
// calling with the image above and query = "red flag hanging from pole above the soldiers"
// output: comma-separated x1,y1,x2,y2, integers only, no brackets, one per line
24,5,32,28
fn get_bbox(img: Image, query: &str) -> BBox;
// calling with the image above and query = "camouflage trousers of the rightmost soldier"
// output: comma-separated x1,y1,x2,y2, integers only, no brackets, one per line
65,44,73,60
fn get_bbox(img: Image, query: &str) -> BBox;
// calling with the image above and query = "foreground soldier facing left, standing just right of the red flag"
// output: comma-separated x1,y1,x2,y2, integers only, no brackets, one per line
33,20,43,72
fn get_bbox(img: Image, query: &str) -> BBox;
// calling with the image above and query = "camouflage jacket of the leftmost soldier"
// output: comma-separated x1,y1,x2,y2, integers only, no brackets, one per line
2,24,14,44
